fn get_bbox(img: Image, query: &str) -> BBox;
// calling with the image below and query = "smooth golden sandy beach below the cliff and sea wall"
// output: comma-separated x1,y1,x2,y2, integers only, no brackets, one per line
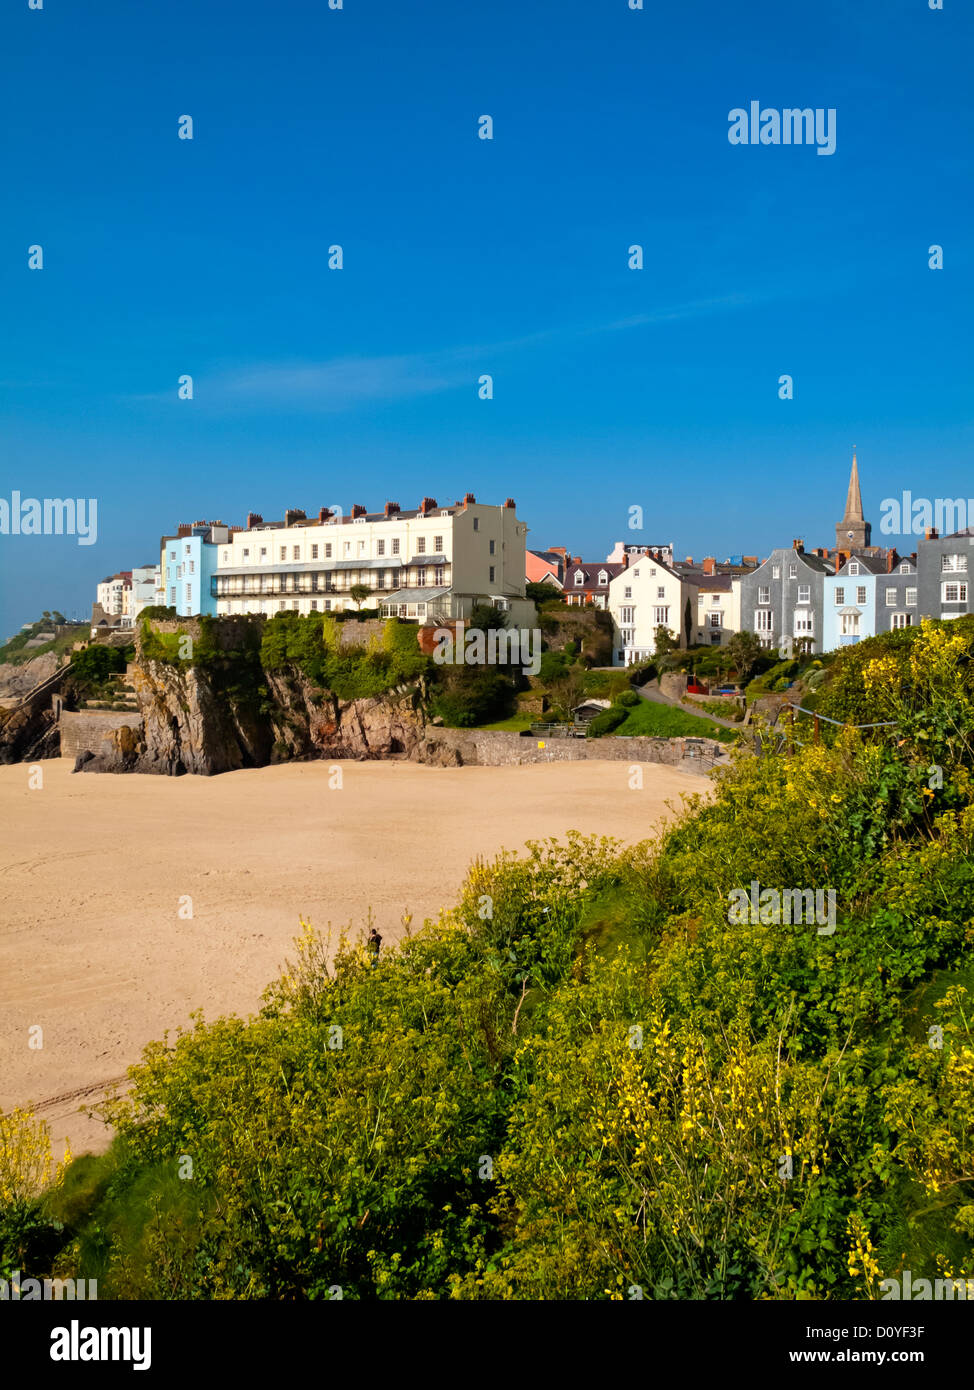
0,759,707,1152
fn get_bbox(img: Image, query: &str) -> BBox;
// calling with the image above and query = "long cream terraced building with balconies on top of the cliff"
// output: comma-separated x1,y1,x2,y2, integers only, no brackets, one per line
210,492,536,627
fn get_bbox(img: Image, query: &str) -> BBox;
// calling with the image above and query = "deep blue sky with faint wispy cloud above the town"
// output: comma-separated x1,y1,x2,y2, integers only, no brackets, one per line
0,0,974,637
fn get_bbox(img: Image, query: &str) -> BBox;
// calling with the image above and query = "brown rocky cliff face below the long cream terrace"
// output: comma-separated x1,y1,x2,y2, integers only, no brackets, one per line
76,660,460,776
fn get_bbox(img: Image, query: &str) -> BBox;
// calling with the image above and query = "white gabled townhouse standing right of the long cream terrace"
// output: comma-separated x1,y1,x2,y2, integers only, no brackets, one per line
607,555,686,666
